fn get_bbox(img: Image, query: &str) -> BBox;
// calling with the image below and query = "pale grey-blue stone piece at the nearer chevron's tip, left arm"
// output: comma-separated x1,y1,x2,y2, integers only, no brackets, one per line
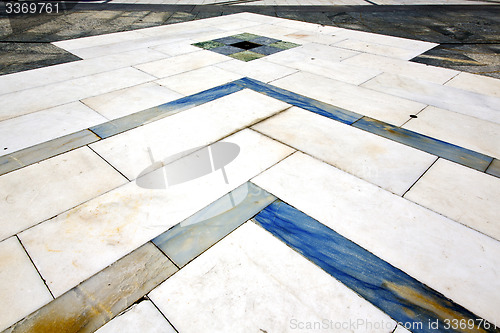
152,182,276,267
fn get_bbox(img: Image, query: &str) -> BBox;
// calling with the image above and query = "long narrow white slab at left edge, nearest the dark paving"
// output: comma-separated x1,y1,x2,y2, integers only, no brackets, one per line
0,49,167,94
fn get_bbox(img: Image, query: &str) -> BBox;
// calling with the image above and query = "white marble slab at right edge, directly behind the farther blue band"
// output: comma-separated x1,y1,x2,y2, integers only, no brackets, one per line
402,106,500,158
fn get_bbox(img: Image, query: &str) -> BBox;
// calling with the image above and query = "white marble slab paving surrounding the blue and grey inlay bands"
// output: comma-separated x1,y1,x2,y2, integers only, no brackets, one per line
0,11,500,332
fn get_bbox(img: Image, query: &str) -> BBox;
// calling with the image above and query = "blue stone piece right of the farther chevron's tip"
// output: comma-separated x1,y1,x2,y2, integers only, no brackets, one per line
234,77,363,125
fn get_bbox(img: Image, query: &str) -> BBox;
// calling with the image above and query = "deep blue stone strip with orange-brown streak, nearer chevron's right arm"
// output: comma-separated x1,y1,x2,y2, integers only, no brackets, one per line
254,200,500,333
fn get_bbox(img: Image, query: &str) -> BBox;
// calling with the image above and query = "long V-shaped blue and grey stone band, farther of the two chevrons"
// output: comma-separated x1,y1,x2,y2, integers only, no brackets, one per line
0,77,500,178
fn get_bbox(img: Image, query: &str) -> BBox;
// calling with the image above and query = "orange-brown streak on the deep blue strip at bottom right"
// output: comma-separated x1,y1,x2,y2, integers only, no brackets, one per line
384,282,487,333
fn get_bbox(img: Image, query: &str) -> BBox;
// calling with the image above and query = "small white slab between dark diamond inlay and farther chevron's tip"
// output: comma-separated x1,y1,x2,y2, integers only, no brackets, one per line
215,58,297,82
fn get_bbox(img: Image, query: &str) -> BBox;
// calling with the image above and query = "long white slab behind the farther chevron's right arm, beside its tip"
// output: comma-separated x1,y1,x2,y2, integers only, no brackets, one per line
272,72,426,126
